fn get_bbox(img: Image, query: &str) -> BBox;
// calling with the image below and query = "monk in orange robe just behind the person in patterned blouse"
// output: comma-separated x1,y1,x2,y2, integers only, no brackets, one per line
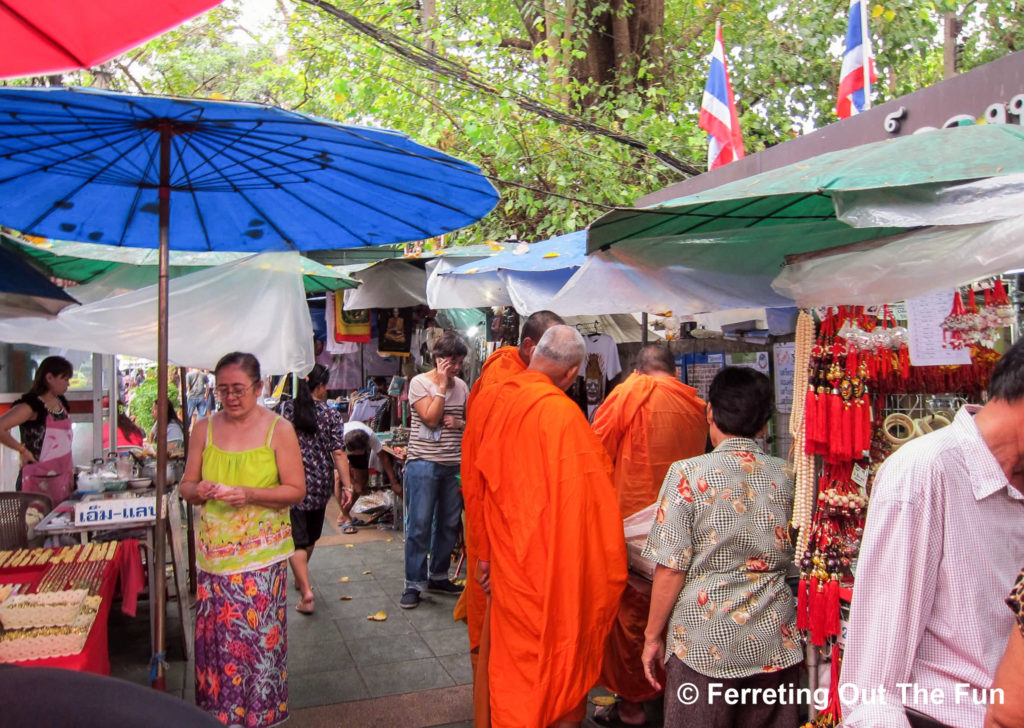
594,344,708,726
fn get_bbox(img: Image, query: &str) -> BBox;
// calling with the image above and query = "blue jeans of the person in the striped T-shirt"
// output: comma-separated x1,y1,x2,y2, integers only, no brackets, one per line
403,460,462,592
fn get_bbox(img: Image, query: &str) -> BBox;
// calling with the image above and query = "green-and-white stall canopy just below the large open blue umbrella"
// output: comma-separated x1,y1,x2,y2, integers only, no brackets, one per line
0,233,359,293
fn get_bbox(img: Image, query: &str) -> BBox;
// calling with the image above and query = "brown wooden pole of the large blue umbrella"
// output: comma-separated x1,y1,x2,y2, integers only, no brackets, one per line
150,120,173,690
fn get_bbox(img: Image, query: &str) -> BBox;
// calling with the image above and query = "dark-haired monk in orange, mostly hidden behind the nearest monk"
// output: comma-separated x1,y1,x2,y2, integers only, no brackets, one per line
454,311,564,659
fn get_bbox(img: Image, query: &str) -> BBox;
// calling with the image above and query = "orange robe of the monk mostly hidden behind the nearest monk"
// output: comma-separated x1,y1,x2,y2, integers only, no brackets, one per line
453,346,526,652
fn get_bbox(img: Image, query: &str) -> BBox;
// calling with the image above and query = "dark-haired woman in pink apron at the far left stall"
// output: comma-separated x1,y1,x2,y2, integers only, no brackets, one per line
0,356,75,506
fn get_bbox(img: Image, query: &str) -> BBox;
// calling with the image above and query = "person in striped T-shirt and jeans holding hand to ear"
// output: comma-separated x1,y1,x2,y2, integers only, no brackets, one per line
399,331,469,609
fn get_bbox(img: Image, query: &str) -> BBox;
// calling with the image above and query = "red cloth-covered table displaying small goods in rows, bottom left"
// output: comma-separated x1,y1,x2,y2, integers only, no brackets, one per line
0,540,143,675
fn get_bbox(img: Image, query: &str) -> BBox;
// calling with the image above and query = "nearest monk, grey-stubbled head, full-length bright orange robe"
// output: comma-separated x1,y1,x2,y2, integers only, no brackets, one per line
463,326,626,728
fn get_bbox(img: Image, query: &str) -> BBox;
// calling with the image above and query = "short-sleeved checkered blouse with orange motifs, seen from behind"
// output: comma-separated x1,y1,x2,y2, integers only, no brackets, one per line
643,437,803,679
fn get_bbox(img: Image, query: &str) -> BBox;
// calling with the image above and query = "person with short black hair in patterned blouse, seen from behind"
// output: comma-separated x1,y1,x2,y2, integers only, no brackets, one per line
643,367,803,728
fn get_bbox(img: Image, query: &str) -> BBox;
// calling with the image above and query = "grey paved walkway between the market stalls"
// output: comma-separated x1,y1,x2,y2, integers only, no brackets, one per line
110,497,472,728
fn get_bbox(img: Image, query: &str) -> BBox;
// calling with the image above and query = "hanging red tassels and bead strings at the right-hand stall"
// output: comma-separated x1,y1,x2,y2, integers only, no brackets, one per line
791,280,1016,727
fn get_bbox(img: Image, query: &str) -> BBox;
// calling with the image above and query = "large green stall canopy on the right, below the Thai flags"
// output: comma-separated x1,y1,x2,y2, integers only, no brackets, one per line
587,125,1024,255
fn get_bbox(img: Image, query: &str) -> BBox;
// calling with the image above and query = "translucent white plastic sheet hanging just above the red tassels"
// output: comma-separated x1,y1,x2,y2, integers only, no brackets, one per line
772,216,1024,306
